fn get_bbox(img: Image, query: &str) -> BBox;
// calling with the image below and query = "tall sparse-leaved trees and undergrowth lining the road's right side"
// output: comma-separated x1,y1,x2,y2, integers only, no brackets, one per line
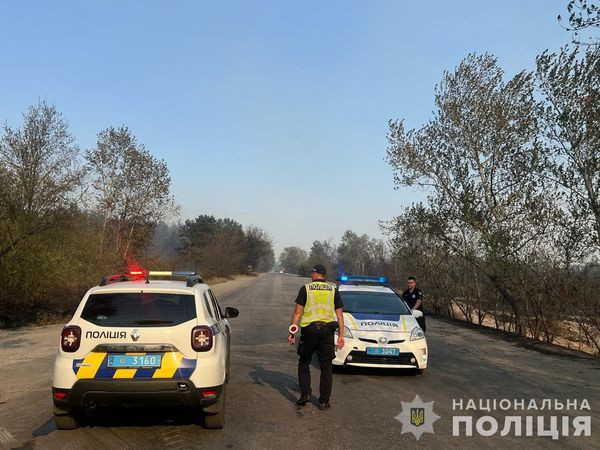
387,46,600,352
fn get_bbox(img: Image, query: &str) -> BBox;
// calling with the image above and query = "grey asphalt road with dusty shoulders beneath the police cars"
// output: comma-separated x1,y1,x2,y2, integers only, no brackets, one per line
0,274,600,449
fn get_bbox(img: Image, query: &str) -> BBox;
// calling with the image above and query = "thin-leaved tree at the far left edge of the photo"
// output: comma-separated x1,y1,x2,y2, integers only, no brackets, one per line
0,101,83,258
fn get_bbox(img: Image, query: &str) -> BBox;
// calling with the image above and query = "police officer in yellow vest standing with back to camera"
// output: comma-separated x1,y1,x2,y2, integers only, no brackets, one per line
288,264,344,410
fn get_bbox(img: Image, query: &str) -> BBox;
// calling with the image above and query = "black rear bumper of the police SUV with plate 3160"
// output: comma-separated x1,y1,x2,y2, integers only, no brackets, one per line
52,379,223,414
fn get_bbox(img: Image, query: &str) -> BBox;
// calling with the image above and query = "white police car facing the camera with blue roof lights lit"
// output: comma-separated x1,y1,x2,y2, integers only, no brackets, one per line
333,276,427,373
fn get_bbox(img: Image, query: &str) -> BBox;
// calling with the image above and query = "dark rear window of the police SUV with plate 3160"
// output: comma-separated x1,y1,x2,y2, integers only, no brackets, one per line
81,292,196,327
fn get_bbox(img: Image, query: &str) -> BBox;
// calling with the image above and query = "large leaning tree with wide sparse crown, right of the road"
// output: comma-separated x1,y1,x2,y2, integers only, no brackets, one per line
388,55,552,332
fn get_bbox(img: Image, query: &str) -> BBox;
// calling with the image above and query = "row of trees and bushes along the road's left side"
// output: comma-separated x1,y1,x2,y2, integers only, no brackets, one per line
0,101,274,327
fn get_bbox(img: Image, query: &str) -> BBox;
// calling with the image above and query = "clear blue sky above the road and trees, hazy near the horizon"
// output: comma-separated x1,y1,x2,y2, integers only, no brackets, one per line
0,0,570,252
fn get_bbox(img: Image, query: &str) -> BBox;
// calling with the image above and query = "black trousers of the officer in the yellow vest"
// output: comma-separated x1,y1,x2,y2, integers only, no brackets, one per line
298,322,337,402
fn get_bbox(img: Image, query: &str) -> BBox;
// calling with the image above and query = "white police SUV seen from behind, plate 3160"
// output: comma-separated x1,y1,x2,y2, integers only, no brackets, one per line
52,270,238,429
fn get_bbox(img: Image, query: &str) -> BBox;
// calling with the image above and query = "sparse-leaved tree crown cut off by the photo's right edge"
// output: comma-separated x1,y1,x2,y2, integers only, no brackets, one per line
536,48,600,256
